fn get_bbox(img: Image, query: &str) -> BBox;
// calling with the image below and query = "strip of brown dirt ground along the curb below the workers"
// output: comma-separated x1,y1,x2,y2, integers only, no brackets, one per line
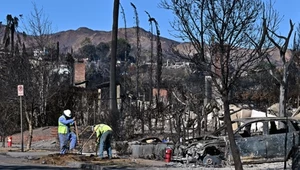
0,148,291,170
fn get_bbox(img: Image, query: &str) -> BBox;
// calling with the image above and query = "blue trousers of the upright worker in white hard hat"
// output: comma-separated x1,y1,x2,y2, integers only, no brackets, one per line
58,132,77,154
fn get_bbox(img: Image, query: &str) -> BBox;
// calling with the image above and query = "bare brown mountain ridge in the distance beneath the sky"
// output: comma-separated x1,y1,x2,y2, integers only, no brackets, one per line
0,26,291,65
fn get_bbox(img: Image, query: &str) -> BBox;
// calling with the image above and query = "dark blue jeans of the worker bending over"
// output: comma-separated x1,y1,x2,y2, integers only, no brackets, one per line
99,130,112,158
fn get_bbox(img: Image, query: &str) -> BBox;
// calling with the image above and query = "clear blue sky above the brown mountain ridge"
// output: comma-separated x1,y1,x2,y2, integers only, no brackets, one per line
0,0,300,39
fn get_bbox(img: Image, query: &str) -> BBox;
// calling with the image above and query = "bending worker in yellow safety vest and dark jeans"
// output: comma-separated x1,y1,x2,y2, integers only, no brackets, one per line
93,124,112,159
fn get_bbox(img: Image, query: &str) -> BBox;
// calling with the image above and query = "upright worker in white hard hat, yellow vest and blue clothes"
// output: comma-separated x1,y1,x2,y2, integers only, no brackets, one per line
58,109,77,154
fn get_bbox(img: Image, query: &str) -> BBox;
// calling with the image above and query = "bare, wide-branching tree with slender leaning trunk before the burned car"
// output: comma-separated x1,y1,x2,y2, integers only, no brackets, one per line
160,0,274,170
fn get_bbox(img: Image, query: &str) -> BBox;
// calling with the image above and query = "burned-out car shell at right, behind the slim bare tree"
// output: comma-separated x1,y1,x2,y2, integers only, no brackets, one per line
174,117,300,166
